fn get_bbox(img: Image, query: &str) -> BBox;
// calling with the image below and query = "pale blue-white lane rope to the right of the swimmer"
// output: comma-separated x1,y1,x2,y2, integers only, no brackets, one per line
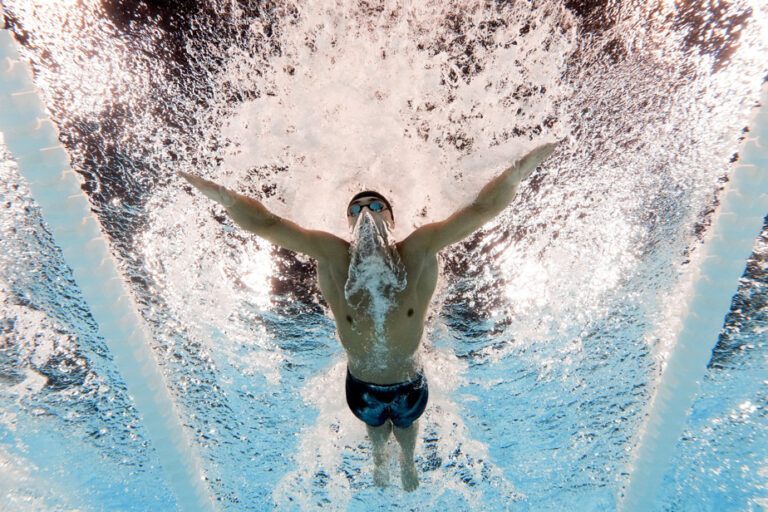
621,86,768,511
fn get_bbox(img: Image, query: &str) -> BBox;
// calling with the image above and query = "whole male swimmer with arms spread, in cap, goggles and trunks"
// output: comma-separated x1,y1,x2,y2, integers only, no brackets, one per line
180,144,556,492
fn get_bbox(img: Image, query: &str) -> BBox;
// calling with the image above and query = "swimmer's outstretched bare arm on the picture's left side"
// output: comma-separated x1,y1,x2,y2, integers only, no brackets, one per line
179,171,349,260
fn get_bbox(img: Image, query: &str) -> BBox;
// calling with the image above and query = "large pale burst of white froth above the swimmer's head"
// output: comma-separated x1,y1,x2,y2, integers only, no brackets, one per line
201,2,574,237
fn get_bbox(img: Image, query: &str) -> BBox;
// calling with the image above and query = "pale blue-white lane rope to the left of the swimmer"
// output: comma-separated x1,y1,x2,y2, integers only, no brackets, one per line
0,30,214,511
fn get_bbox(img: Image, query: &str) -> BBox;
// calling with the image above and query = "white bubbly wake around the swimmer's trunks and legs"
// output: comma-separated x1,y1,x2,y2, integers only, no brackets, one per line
272,349,522,511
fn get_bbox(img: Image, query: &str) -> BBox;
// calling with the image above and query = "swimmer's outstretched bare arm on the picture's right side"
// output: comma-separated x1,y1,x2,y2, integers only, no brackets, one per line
403,143,557,253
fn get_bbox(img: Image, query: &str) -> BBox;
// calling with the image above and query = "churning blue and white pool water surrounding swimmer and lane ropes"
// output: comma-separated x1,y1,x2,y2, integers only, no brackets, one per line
0,1,768,510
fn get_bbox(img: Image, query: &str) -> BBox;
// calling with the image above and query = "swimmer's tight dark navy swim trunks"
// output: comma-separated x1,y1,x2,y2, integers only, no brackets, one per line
346,369,429,428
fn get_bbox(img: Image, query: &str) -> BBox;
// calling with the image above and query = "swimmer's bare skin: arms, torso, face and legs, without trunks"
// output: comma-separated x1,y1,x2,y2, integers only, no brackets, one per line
180,144,556,491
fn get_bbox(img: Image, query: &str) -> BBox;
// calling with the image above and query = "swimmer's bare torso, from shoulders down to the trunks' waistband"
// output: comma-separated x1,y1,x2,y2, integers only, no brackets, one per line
318,244,438,384
